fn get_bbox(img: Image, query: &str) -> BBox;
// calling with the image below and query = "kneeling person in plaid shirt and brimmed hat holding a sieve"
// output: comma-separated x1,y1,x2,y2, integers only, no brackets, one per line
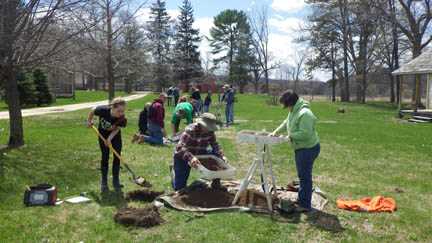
172,113,223,191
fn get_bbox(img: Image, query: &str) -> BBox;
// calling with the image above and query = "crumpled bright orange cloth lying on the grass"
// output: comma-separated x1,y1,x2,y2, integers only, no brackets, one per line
336,196,396,213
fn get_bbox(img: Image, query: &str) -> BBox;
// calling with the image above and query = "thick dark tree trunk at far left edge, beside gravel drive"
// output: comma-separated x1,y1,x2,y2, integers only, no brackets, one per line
4,68,24,148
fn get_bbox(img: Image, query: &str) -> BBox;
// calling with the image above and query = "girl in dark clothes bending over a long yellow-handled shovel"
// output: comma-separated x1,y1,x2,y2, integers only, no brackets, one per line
87,98,127,192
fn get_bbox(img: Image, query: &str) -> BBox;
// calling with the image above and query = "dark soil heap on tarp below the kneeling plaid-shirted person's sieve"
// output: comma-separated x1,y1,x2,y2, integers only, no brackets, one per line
178,186,234,208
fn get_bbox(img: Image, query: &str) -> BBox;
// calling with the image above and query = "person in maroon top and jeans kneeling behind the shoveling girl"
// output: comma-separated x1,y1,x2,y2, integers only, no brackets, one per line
143,93,166,145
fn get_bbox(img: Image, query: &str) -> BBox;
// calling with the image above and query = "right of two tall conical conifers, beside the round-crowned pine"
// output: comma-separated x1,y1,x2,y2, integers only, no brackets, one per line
174,0,202,87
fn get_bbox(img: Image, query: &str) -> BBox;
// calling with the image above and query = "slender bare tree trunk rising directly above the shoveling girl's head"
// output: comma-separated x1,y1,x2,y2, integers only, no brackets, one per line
106,4,115,101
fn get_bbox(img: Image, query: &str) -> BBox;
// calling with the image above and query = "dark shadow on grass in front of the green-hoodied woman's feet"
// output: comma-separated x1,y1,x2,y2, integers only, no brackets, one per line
307,210,345,233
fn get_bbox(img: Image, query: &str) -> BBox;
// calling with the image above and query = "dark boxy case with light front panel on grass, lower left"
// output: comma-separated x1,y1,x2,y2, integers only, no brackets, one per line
24,184,57,206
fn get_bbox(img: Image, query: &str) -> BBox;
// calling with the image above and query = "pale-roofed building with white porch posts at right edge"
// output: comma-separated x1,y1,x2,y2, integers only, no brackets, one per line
392,51,432,110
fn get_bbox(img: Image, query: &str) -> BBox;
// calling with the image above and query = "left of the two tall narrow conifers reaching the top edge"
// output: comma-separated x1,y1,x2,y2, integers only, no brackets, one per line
148,0,172,91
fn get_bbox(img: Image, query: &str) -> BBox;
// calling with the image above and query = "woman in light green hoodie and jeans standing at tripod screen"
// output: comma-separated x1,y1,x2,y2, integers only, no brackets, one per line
271,91,321,212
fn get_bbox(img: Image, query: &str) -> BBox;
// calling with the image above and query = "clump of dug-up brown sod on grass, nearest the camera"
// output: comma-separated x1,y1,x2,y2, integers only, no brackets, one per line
114,206,164,228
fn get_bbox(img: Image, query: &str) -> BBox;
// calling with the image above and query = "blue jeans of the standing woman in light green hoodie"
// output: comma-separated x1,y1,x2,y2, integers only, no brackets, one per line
295,144,321,209
